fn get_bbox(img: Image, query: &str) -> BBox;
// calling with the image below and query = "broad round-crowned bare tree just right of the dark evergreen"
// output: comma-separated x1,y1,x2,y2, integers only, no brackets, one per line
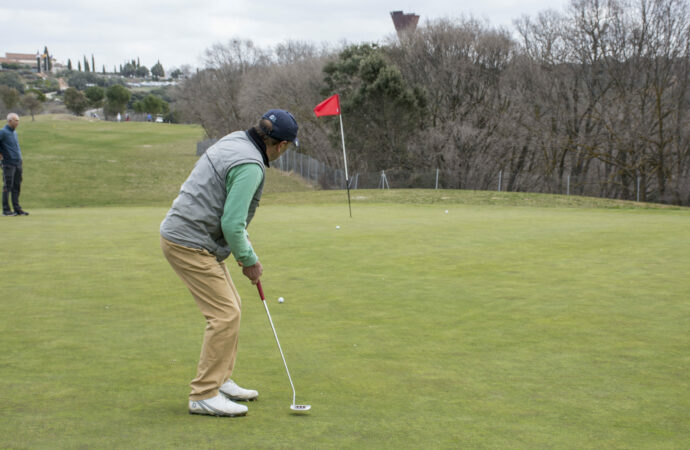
389,19,515,187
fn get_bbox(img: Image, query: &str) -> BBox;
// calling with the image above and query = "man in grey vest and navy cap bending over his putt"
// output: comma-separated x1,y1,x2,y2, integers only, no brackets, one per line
160,109,299,417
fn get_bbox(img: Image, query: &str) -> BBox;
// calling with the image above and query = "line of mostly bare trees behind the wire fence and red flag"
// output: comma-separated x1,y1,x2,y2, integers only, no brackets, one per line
176,0,690,205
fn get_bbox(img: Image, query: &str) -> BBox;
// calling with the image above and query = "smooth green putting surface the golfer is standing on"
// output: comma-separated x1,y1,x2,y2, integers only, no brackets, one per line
0,203,690,448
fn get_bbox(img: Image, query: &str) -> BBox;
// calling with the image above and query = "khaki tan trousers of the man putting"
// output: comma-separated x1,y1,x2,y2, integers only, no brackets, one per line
161,238,242,401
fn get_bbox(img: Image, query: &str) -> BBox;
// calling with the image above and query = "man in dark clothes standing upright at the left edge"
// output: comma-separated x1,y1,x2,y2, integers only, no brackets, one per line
0,113,29,216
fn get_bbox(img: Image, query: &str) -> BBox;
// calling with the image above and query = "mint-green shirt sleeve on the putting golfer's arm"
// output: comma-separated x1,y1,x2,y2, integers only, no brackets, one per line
221,163,263,267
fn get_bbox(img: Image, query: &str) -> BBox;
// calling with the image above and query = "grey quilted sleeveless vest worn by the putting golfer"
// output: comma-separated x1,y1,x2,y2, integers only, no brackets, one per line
161,131,266,261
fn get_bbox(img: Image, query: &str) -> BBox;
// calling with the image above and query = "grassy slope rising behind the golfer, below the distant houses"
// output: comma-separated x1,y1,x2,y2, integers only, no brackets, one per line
18,116,310,210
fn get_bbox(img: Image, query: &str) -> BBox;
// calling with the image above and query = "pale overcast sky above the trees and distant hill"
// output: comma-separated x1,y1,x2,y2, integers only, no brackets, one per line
0,0,569,71
